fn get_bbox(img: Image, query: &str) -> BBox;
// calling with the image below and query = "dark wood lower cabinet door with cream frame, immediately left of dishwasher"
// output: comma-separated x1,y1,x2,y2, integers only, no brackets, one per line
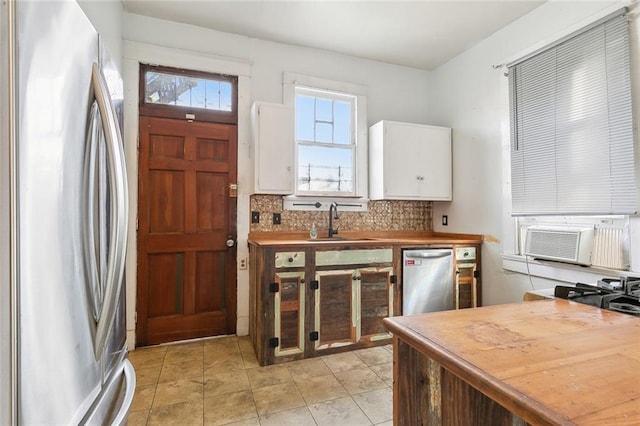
356,267,393,340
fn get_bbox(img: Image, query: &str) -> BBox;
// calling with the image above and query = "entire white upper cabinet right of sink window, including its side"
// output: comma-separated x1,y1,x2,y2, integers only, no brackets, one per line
369,121,452,201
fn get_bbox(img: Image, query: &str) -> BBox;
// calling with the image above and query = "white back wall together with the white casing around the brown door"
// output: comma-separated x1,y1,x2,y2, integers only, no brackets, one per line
123,13,429,347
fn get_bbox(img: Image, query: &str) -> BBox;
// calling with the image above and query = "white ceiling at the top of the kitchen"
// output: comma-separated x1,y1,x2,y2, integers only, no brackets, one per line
122,0,544,70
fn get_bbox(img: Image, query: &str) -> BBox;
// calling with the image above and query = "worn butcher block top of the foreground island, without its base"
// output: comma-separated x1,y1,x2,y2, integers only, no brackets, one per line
384,299,640,425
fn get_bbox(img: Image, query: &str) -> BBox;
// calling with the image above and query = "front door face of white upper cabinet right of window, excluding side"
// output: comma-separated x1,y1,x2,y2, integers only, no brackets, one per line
384,122,451,200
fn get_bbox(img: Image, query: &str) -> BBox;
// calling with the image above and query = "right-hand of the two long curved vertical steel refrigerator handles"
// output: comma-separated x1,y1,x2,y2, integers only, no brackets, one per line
91,63,129,359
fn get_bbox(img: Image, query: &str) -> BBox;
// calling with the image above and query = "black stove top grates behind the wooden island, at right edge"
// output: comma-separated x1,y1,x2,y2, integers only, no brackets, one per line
554,277,640,317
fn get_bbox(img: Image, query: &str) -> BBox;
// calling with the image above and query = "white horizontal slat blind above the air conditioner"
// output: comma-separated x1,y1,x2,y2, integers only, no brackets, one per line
509,10,637,216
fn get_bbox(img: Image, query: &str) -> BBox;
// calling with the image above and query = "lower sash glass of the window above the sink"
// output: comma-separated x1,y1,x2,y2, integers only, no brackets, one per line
298,145,353,193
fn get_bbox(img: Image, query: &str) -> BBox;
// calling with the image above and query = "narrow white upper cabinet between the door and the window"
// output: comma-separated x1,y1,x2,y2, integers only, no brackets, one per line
251,102,295,195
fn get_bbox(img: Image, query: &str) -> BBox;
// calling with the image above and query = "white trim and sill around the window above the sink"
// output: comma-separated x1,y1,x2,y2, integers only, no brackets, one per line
283,73,369,211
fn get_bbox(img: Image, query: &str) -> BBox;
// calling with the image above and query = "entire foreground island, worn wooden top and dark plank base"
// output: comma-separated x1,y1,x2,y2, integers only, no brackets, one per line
384,299,640,425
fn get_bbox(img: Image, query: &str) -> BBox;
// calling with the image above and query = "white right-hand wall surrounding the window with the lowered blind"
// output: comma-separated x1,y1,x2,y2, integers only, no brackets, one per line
428,1,640,304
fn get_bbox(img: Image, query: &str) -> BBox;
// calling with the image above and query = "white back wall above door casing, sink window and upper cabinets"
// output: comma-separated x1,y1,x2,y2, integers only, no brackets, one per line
124,13,429,124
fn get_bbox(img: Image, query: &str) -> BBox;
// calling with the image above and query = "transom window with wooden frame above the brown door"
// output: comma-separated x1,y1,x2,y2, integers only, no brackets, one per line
140,64,238,124
